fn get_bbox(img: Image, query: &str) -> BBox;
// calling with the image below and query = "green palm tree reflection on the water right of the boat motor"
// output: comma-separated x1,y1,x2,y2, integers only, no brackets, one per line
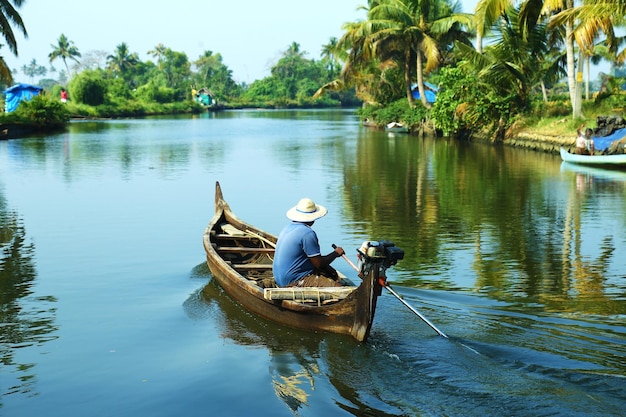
344,133,626,314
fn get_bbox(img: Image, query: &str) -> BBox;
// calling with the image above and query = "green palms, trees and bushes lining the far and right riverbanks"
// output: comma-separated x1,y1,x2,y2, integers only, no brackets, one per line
0,0,626,141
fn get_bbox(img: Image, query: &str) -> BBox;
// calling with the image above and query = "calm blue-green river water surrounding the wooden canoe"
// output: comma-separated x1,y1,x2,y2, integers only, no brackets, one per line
0,110,626,417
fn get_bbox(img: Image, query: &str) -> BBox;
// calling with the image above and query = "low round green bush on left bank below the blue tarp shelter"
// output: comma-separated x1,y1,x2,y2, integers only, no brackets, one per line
15,94,69,129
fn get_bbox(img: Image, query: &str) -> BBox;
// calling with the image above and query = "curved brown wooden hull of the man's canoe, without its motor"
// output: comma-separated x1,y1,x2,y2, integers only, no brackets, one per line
204,183,382,342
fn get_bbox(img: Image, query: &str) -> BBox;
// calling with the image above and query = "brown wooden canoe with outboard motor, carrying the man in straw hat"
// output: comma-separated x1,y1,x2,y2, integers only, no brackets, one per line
204,182,395,342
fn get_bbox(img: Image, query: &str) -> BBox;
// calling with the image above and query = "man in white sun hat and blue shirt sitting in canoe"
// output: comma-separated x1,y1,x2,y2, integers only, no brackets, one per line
273,198,345,287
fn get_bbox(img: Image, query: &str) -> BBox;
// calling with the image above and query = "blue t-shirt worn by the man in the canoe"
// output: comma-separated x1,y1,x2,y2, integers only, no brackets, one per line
273,222,321,287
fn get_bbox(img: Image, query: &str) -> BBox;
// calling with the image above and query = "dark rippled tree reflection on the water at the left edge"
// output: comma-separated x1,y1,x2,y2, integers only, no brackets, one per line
0,195,57,400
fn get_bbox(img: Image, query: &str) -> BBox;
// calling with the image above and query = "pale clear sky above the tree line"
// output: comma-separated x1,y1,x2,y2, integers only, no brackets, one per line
0,0,476,84
